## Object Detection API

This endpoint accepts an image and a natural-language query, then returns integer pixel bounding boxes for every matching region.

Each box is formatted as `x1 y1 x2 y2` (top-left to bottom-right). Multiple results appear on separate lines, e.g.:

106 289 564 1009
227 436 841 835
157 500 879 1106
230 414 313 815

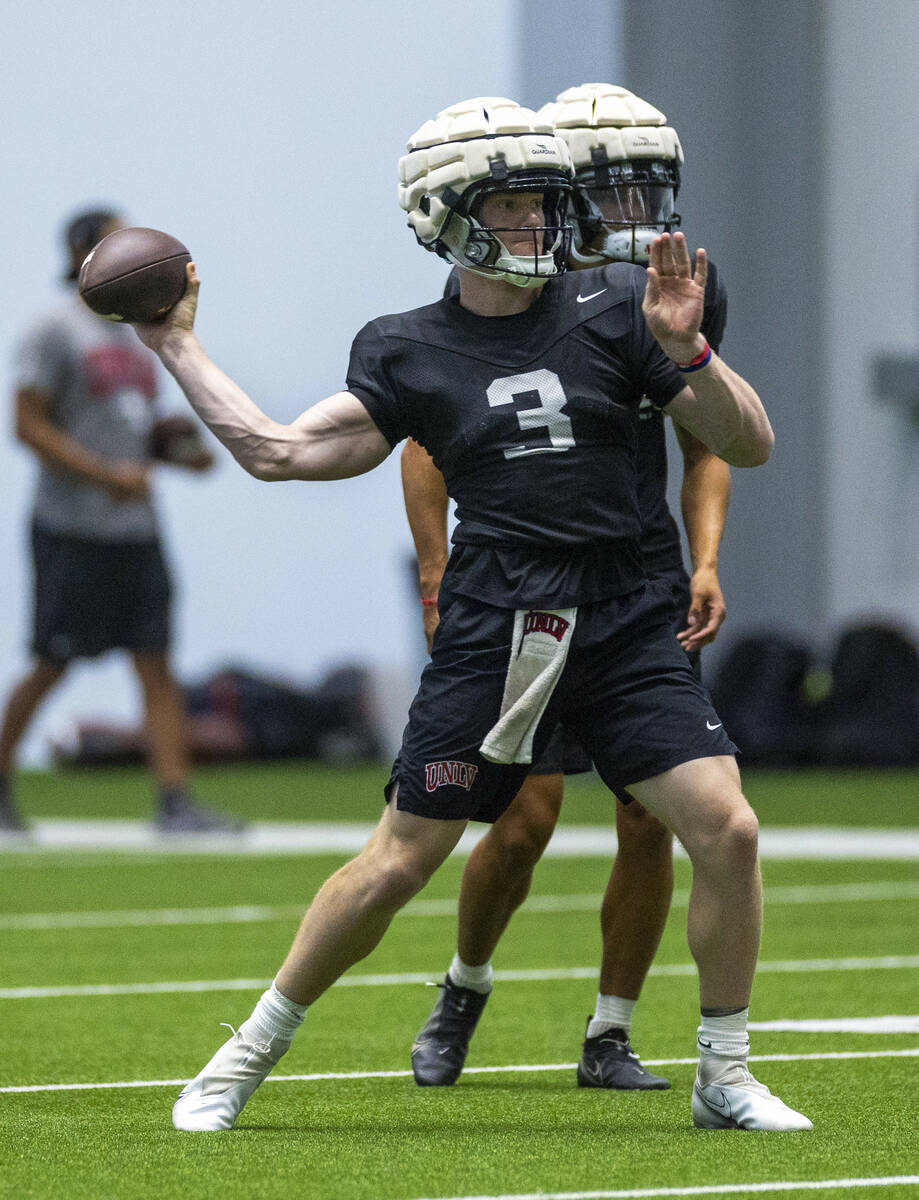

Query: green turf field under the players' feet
0 766 919 1200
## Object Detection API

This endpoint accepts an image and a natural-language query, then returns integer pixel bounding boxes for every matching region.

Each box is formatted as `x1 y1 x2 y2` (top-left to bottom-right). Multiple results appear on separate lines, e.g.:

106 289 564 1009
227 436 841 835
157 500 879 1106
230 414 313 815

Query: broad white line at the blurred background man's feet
0 820 919 862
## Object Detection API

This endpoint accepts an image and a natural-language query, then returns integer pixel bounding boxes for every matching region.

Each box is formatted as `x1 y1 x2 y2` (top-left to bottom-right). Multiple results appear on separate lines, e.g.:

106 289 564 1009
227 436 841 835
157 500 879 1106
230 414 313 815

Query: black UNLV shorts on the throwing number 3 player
386 582 737 822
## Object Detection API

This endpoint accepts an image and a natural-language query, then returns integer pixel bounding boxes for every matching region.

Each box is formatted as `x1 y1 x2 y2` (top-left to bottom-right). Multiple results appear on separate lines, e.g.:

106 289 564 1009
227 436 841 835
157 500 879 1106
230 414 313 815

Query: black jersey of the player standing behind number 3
444 259 727 581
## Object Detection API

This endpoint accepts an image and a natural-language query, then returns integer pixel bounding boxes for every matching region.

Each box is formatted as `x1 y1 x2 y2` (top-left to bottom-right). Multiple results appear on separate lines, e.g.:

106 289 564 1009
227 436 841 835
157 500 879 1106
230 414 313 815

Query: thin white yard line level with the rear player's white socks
0 954 919 1000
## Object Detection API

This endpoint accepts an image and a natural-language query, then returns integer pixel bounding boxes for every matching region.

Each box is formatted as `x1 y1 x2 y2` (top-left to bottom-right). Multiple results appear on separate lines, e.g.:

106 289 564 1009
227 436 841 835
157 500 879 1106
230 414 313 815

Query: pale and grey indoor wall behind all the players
0 0 919 762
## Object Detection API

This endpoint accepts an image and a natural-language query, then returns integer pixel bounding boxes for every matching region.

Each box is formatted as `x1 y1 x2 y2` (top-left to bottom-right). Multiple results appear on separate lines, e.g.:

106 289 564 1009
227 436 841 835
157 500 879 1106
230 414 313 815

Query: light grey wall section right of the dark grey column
823 0 919 634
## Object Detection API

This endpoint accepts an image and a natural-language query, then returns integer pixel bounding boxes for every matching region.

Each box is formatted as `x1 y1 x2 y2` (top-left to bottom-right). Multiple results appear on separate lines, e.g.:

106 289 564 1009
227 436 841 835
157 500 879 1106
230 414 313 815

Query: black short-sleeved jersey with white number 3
347 263 686 607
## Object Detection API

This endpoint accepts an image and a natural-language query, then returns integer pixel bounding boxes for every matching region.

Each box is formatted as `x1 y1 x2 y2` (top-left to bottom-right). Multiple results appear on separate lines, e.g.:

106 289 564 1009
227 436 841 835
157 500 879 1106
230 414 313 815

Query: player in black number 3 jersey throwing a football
138 97 811 1129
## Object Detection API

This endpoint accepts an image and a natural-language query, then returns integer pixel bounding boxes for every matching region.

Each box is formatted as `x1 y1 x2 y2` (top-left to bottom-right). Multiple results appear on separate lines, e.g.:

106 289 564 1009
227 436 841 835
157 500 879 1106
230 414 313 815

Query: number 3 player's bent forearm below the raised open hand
666 352 775 467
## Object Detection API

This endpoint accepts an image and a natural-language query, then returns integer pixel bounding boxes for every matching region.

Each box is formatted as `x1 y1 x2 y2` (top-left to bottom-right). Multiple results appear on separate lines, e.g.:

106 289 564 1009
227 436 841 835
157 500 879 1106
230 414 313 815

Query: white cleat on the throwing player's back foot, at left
173 1032 290 1132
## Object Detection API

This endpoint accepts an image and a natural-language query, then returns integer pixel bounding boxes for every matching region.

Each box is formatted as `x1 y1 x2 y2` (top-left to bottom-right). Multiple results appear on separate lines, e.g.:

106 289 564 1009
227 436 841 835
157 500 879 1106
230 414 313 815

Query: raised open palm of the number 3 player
642 233 708 362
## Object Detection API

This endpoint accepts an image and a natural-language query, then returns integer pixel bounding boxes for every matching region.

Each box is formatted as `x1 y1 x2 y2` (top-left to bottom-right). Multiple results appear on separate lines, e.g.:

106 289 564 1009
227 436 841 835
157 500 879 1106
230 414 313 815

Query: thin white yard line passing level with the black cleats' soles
0 1048 919 1096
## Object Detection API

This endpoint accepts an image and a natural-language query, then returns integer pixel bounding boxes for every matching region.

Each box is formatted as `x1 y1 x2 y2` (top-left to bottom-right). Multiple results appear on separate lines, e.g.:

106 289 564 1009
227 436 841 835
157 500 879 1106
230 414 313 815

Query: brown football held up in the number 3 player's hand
77 228 192 322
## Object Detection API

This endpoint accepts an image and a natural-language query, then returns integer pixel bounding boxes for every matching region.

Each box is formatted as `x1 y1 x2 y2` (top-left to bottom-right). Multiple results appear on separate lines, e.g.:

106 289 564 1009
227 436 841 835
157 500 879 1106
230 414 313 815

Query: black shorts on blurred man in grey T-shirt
31 524 172 664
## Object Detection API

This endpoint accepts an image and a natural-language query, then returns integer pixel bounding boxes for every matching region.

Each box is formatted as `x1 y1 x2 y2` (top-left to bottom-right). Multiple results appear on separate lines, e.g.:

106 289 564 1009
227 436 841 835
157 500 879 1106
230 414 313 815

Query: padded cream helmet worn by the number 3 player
398 96 572 288
